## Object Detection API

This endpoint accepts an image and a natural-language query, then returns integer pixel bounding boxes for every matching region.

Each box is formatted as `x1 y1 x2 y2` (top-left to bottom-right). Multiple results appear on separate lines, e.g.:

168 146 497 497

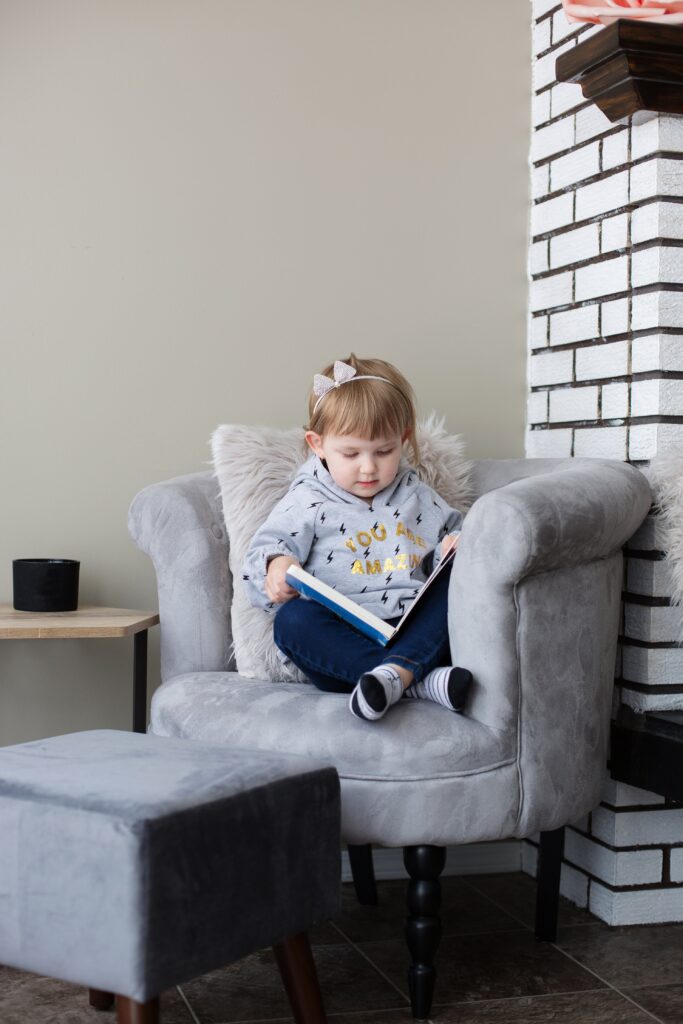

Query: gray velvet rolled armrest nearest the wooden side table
128 472 234 681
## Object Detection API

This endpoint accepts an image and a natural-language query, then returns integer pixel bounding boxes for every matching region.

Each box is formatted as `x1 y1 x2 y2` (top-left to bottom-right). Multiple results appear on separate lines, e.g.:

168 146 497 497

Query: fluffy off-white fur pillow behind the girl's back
211 413 473 682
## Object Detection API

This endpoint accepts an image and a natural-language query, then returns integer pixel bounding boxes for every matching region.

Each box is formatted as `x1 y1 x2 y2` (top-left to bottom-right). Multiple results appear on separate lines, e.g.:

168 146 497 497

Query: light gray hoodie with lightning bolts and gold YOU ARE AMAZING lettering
242 455 463 618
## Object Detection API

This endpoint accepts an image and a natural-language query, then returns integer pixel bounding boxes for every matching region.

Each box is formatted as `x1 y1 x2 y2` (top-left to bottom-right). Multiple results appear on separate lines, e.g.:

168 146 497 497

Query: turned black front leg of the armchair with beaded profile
403 846 445 1021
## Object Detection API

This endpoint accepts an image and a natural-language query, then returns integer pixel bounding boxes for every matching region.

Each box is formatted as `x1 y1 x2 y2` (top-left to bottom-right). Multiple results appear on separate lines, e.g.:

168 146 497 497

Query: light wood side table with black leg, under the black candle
0 604 159 732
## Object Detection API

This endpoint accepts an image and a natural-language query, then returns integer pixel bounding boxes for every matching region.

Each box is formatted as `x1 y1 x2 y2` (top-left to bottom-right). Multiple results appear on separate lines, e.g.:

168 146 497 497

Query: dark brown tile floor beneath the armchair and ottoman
0 874 683 1024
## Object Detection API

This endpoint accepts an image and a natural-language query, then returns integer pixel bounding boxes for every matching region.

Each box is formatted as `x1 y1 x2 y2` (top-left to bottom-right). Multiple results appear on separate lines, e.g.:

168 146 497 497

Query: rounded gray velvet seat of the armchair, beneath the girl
151 672 518 846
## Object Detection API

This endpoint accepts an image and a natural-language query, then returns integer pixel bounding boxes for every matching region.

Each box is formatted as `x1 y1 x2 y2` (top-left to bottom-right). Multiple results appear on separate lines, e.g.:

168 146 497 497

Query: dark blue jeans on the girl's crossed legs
272 566 451 693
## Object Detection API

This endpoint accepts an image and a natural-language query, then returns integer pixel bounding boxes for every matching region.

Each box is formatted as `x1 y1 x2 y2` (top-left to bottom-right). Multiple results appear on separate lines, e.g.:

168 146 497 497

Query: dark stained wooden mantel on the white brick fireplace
555 18 683 121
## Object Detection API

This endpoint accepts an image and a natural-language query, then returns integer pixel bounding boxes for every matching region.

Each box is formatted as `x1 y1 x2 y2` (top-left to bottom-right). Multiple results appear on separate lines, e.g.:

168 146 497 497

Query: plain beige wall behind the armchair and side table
0 0 529 743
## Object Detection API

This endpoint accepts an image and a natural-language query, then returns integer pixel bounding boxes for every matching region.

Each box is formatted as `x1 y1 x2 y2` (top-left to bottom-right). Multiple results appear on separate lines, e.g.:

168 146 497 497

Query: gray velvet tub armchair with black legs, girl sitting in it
129 459 651 1020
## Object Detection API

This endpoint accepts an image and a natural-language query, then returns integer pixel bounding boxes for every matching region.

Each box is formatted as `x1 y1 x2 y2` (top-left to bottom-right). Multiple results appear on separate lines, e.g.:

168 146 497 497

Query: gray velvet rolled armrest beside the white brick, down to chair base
449 460 651 835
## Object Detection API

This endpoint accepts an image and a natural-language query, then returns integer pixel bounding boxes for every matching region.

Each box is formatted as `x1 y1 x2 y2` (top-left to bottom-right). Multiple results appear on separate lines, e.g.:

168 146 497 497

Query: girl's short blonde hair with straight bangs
304 352 420 466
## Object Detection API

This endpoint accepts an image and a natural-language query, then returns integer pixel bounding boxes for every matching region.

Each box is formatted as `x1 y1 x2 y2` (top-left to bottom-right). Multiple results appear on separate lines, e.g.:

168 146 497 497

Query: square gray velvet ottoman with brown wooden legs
0 730 340 1022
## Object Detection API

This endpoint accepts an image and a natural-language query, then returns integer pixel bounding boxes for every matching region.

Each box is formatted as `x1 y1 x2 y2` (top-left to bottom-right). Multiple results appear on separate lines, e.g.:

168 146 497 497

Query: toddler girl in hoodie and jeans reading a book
243 354 472 721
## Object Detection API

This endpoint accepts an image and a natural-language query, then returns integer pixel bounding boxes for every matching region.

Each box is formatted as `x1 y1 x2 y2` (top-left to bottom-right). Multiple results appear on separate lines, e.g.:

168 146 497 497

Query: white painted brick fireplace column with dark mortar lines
524 0 683 925
